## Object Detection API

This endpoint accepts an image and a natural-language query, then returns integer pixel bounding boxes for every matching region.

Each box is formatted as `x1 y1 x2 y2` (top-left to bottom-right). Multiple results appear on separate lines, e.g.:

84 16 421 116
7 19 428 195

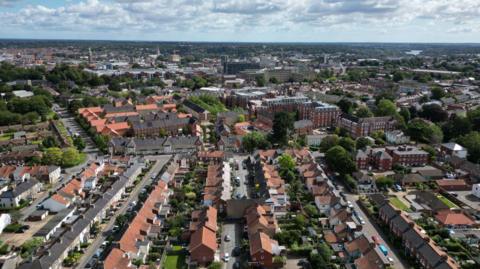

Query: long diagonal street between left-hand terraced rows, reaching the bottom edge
75 155 171 268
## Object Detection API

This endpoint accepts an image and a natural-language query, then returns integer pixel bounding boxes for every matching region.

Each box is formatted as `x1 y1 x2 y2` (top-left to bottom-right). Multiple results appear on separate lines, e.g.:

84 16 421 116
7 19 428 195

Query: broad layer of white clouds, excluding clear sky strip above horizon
0 0 480 41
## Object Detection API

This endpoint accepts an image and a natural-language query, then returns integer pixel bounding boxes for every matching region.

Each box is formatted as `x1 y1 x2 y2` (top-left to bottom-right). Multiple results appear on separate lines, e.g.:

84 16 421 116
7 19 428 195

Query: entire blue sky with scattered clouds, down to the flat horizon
0 0 480 43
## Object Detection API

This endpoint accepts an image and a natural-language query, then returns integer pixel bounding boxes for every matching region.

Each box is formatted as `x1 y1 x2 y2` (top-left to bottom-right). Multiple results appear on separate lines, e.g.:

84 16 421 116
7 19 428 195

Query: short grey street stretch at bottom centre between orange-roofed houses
220 222 242 269
